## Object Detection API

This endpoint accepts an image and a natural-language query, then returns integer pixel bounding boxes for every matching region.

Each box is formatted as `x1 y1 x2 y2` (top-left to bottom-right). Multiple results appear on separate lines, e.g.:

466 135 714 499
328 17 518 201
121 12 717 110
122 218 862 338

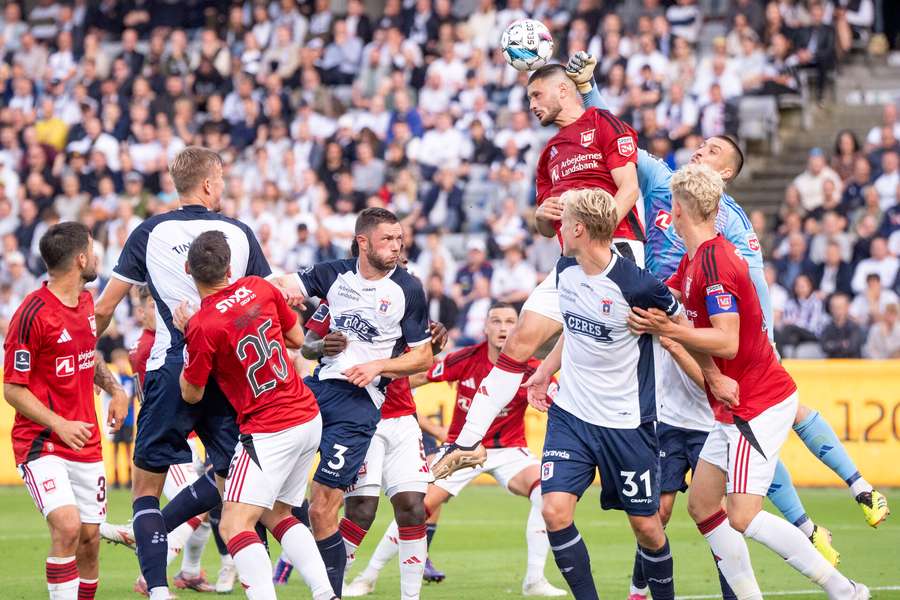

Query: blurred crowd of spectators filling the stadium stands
0 0 884 355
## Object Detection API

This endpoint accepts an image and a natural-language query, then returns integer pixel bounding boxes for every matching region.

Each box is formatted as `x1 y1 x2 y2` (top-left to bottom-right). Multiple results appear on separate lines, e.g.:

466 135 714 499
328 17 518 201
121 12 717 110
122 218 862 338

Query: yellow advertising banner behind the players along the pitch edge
0 360 900 486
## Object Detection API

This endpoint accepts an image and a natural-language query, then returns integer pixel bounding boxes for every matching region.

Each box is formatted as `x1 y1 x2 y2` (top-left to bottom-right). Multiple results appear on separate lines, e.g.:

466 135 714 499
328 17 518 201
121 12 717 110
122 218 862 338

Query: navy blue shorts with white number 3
303 375 381 490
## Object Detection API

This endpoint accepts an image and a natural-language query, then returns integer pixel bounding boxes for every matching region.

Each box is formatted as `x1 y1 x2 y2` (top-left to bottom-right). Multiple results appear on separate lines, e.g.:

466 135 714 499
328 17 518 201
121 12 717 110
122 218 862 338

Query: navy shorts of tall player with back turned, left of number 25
134 361 238 477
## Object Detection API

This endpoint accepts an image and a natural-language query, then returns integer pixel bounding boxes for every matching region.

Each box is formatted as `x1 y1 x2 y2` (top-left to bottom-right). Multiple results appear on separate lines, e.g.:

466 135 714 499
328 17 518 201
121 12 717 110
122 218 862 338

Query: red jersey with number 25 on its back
184 276 319 433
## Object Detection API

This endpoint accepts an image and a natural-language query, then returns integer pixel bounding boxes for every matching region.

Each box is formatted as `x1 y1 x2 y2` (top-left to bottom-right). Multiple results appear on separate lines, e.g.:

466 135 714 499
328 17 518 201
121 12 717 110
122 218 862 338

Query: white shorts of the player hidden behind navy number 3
344 415 433 498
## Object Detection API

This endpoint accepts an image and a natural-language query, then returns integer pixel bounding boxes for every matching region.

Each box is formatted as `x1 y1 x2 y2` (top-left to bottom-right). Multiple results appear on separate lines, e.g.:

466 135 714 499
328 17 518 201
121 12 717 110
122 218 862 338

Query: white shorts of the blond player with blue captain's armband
700 392 800 496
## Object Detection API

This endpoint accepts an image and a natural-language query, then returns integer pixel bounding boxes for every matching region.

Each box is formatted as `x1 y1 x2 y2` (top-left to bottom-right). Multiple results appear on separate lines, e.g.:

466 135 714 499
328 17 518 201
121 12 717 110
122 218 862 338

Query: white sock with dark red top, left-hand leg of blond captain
697 510 760 600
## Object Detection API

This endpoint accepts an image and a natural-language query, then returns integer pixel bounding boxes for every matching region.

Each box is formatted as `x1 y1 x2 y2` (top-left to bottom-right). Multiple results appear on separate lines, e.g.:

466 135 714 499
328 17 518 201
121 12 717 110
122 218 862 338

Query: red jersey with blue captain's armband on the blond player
667 235 797 423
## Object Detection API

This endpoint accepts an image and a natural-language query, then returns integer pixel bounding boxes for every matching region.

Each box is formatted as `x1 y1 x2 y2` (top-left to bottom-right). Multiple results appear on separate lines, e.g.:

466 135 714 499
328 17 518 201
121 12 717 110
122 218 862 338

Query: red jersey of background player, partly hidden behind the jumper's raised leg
428 342 556 448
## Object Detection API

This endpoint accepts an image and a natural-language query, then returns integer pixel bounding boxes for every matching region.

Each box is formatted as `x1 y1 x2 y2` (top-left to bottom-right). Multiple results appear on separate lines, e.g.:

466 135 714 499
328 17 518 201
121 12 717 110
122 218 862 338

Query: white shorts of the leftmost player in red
19 455 106 523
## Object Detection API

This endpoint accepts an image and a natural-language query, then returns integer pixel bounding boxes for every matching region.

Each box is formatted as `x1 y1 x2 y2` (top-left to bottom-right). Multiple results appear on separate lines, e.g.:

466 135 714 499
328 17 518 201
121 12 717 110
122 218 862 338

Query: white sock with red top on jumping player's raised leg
456 352 528 448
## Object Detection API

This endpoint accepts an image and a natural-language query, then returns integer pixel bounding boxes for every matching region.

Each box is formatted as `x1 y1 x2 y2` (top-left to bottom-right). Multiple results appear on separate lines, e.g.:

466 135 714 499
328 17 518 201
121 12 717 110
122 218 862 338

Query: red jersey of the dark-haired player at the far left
3 283 103 464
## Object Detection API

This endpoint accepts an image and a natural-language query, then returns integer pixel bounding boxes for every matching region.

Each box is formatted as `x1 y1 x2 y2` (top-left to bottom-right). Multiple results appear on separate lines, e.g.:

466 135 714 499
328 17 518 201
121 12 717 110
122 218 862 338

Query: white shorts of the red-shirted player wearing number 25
224 415 322 508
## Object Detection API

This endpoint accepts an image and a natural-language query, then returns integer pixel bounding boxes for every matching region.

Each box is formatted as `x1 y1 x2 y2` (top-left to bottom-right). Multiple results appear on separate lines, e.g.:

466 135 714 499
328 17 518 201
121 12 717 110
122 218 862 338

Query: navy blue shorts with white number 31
541 404 659 516
